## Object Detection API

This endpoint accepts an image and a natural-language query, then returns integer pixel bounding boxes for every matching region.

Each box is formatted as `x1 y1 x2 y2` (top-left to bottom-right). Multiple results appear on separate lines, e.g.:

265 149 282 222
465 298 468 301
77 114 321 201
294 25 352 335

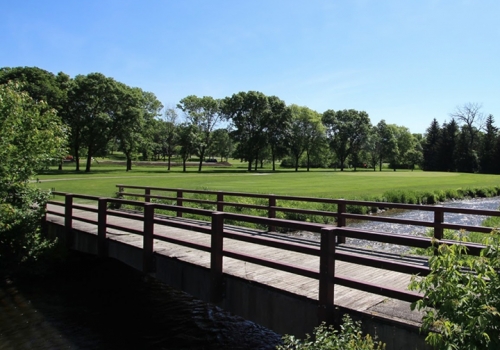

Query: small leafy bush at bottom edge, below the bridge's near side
277 315 385 350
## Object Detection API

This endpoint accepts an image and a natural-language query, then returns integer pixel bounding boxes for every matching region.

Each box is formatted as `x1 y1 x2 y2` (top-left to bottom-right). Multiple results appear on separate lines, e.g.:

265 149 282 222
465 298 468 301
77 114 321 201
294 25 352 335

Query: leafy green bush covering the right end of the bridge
409 232 500 350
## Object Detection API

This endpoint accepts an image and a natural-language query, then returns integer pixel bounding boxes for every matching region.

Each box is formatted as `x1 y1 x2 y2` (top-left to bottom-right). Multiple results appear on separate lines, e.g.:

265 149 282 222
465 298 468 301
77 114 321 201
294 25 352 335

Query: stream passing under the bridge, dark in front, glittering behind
0 197 500 350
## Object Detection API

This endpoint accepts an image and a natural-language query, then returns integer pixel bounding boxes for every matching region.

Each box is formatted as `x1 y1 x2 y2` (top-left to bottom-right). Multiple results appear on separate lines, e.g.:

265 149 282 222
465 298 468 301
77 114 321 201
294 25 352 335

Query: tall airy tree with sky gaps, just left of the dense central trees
177 95 221 171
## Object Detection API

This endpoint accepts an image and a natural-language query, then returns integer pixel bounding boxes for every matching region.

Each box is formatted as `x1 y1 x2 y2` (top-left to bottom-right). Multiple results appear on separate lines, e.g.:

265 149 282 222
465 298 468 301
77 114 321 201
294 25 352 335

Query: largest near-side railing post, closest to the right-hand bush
318 227 336 324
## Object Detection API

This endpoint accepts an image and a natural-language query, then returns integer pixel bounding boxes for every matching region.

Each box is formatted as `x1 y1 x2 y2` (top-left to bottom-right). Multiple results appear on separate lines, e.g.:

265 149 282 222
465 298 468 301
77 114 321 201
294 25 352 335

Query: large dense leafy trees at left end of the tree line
0 67 163 171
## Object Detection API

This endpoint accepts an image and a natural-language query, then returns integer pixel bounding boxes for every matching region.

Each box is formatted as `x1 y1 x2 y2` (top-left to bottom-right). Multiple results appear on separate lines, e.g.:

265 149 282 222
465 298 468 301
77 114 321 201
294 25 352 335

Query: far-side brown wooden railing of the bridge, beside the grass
116 184 500 243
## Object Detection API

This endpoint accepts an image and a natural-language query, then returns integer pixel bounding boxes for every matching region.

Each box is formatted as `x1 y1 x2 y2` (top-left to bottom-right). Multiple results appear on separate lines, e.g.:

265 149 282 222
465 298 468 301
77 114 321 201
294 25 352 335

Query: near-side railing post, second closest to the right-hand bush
210 212 224 303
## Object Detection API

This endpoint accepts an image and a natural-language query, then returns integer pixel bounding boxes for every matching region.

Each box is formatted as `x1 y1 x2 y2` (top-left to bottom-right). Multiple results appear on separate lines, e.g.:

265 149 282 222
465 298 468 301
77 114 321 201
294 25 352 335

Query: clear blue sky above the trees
0 0 500 133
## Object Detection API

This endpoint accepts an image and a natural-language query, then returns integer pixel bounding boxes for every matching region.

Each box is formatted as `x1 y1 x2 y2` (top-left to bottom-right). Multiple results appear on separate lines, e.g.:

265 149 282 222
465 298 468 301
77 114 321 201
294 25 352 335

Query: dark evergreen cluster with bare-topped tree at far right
422 103 500 174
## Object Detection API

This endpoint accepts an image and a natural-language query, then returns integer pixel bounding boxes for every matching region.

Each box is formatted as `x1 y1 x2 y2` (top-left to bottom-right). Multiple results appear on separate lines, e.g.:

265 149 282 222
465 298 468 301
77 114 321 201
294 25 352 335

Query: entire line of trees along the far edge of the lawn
0 67 500 172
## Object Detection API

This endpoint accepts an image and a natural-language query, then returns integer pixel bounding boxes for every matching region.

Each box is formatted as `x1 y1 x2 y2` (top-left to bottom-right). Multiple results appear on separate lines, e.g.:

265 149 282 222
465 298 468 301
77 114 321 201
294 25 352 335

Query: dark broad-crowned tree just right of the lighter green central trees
322 109 371 171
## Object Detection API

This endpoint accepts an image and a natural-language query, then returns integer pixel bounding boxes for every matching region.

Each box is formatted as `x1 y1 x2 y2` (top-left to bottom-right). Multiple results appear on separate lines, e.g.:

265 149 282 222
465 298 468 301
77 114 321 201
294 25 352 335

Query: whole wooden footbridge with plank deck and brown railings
46 185 500 349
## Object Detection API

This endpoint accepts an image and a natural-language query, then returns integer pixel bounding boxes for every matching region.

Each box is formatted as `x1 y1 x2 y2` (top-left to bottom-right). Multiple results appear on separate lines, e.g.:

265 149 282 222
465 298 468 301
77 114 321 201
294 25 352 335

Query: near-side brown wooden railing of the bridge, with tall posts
47 192 492 324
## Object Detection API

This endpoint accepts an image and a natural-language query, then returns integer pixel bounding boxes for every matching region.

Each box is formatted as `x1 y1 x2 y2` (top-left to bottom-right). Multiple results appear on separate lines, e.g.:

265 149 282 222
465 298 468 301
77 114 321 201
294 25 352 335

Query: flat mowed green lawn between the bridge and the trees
36 164 500 199
